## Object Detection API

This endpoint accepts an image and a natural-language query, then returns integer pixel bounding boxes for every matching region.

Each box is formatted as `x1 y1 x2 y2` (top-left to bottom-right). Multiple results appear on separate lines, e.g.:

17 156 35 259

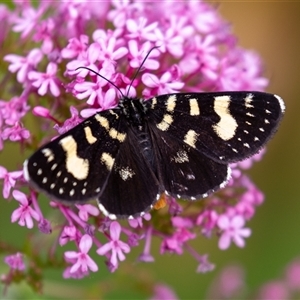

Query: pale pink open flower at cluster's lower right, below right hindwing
218 215 251 250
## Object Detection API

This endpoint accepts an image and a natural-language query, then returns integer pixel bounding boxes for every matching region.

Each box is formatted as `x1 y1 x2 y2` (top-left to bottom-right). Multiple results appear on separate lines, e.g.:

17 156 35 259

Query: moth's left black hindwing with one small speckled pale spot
98 128 161 219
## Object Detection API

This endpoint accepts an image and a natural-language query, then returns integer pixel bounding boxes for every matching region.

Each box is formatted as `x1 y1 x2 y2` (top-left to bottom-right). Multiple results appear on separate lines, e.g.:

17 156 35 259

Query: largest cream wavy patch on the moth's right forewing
212 96 238 141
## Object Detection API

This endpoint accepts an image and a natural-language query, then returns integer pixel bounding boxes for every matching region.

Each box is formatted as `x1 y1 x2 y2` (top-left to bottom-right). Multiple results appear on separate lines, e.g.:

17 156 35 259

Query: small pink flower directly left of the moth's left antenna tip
28 62 60 97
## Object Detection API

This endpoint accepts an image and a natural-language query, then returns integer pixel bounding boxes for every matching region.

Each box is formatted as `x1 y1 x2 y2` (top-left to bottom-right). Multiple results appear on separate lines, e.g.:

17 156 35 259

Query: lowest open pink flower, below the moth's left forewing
64 234 98 273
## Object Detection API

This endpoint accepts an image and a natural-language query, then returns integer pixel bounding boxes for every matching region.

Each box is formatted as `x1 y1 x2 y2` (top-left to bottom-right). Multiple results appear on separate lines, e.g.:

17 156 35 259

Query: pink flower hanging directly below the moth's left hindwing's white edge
97 221 130 268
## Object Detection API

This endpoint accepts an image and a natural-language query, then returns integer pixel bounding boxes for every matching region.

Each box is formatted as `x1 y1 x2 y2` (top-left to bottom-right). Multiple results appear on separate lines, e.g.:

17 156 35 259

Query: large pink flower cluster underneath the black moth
0 0 267 290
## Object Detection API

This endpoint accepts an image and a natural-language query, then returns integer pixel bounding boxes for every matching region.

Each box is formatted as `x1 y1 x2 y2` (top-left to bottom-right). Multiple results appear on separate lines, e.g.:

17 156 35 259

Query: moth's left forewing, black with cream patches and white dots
24 110 127 202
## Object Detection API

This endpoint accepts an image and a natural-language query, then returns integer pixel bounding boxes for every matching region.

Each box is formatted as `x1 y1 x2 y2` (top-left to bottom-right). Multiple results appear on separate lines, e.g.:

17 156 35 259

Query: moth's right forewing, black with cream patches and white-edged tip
148 92 285 163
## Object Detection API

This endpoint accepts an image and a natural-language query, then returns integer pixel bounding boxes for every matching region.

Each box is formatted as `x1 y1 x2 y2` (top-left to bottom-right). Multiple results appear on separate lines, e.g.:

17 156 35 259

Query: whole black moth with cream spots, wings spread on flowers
24 92 285 219
